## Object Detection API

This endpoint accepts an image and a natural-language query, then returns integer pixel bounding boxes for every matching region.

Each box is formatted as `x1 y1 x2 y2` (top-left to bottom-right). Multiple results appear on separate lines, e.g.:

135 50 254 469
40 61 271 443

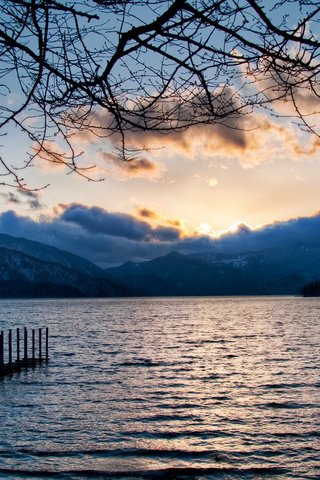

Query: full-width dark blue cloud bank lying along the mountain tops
0 204 320 267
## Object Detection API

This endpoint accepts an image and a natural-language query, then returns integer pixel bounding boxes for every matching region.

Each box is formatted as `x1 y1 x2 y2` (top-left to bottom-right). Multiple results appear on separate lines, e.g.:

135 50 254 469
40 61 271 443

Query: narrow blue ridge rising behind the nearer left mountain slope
0 233 104 277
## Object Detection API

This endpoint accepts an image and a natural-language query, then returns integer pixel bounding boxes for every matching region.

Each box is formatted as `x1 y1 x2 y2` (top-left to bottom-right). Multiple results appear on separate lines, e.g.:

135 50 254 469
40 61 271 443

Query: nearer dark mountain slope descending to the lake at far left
0 238 127 298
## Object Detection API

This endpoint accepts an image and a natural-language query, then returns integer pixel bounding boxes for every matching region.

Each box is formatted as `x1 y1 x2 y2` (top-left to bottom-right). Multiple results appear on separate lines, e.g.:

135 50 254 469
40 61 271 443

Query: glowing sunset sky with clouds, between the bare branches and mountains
0 1 320 267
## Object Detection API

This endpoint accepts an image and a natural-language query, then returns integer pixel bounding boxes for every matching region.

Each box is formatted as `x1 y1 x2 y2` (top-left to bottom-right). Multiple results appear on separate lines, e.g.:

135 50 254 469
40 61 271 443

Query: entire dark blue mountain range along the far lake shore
0 234 320 298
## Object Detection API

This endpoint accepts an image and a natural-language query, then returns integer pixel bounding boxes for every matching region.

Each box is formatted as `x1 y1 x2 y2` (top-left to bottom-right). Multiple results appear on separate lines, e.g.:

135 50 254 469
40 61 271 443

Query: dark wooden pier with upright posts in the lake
0 327 49 378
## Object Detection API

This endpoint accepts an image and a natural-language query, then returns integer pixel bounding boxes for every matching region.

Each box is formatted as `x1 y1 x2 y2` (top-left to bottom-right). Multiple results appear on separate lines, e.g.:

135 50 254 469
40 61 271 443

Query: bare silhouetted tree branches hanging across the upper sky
0 0 320 187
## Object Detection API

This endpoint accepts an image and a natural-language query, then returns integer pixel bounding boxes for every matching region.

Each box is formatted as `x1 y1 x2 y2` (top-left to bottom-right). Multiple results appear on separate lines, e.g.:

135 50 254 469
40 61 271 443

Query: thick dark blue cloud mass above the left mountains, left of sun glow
0 204 181 266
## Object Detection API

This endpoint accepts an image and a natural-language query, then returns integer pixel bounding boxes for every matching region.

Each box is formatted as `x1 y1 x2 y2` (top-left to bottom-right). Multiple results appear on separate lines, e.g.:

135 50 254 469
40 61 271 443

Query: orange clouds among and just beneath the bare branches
69 87 320 172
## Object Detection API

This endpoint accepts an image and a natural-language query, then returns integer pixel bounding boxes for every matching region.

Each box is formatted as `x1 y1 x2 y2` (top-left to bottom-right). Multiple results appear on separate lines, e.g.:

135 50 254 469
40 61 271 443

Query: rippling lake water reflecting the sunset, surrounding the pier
0 297 320 480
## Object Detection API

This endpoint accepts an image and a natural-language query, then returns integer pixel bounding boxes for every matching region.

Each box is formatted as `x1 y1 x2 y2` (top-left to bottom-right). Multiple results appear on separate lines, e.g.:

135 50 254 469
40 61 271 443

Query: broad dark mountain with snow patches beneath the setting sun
106 244 320 296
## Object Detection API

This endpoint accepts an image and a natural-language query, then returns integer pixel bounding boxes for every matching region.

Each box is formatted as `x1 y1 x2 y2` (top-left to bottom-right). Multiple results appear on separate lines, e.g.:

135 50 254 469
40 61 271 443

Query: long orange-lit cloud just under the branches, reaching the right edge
123 113 320 168
